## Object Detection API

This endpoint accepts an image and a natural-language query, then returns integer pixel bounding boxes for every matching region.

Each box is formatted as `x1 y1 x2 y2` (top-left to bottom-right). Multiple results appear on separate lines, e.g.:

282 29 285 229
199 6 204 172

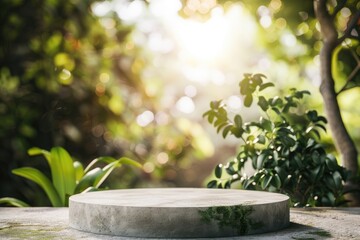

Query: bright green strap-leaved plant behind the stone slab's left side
0 147 141 207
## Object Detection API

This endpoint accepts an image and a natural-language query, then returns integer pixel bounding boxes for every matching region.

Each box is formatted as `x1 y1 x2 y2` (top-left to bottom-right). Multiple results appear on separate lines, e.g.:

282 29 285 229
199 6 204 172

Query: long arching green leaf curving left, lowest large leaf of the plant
12 167 63 207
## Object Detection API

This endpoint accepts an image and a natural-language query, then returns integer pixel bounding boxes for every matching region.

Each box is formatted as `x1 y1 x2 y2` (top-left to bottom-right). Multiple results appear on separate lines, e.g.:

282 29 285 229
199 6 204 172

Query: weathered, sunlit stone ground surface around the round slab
0 207 360 240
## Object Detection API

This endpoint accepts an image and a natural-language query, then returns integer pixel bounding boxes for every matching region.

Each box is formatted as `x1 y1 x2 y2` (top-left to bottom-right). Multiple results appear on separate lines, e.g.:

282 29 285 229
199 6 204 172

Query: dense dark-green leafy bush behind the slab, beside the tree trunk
204 74 347 206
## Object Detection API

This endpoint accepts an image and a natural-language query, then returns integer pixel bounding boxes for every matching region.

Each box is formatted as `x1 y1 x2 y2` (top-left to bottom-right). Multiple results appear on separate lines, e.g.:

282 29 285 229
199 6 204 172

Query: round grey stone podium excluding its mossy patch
69 188 289 238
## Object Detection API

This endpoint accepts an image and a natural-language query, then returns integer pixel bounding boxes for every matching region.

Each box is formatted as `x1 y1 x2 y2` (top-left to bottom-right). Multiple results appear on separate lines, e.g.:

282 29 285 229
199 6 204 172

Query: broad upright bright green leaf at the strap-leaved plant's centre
50 147 76 204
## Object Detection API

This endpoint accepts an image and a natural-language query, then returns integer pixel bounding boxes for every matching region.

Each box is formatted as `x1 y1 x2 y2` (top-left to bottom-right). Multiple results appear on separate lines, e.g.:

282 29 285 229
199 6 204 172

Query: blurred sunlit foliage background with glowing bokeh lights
0 0 360 205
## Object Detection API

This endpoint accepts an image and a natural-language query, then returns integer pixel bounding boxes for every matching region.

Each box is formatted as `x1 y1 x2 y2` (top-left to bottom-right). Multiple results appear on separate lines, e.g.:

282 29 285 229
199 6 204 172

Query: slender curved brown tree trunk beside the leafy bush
314 0 360 206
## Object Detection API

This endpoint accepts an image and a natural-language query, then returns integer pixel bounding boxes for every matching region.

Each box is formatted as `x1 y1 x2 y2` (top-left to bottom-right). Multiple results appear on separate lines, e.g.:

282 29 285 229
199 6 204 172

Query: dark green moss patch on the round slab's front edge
199 205 261 235
